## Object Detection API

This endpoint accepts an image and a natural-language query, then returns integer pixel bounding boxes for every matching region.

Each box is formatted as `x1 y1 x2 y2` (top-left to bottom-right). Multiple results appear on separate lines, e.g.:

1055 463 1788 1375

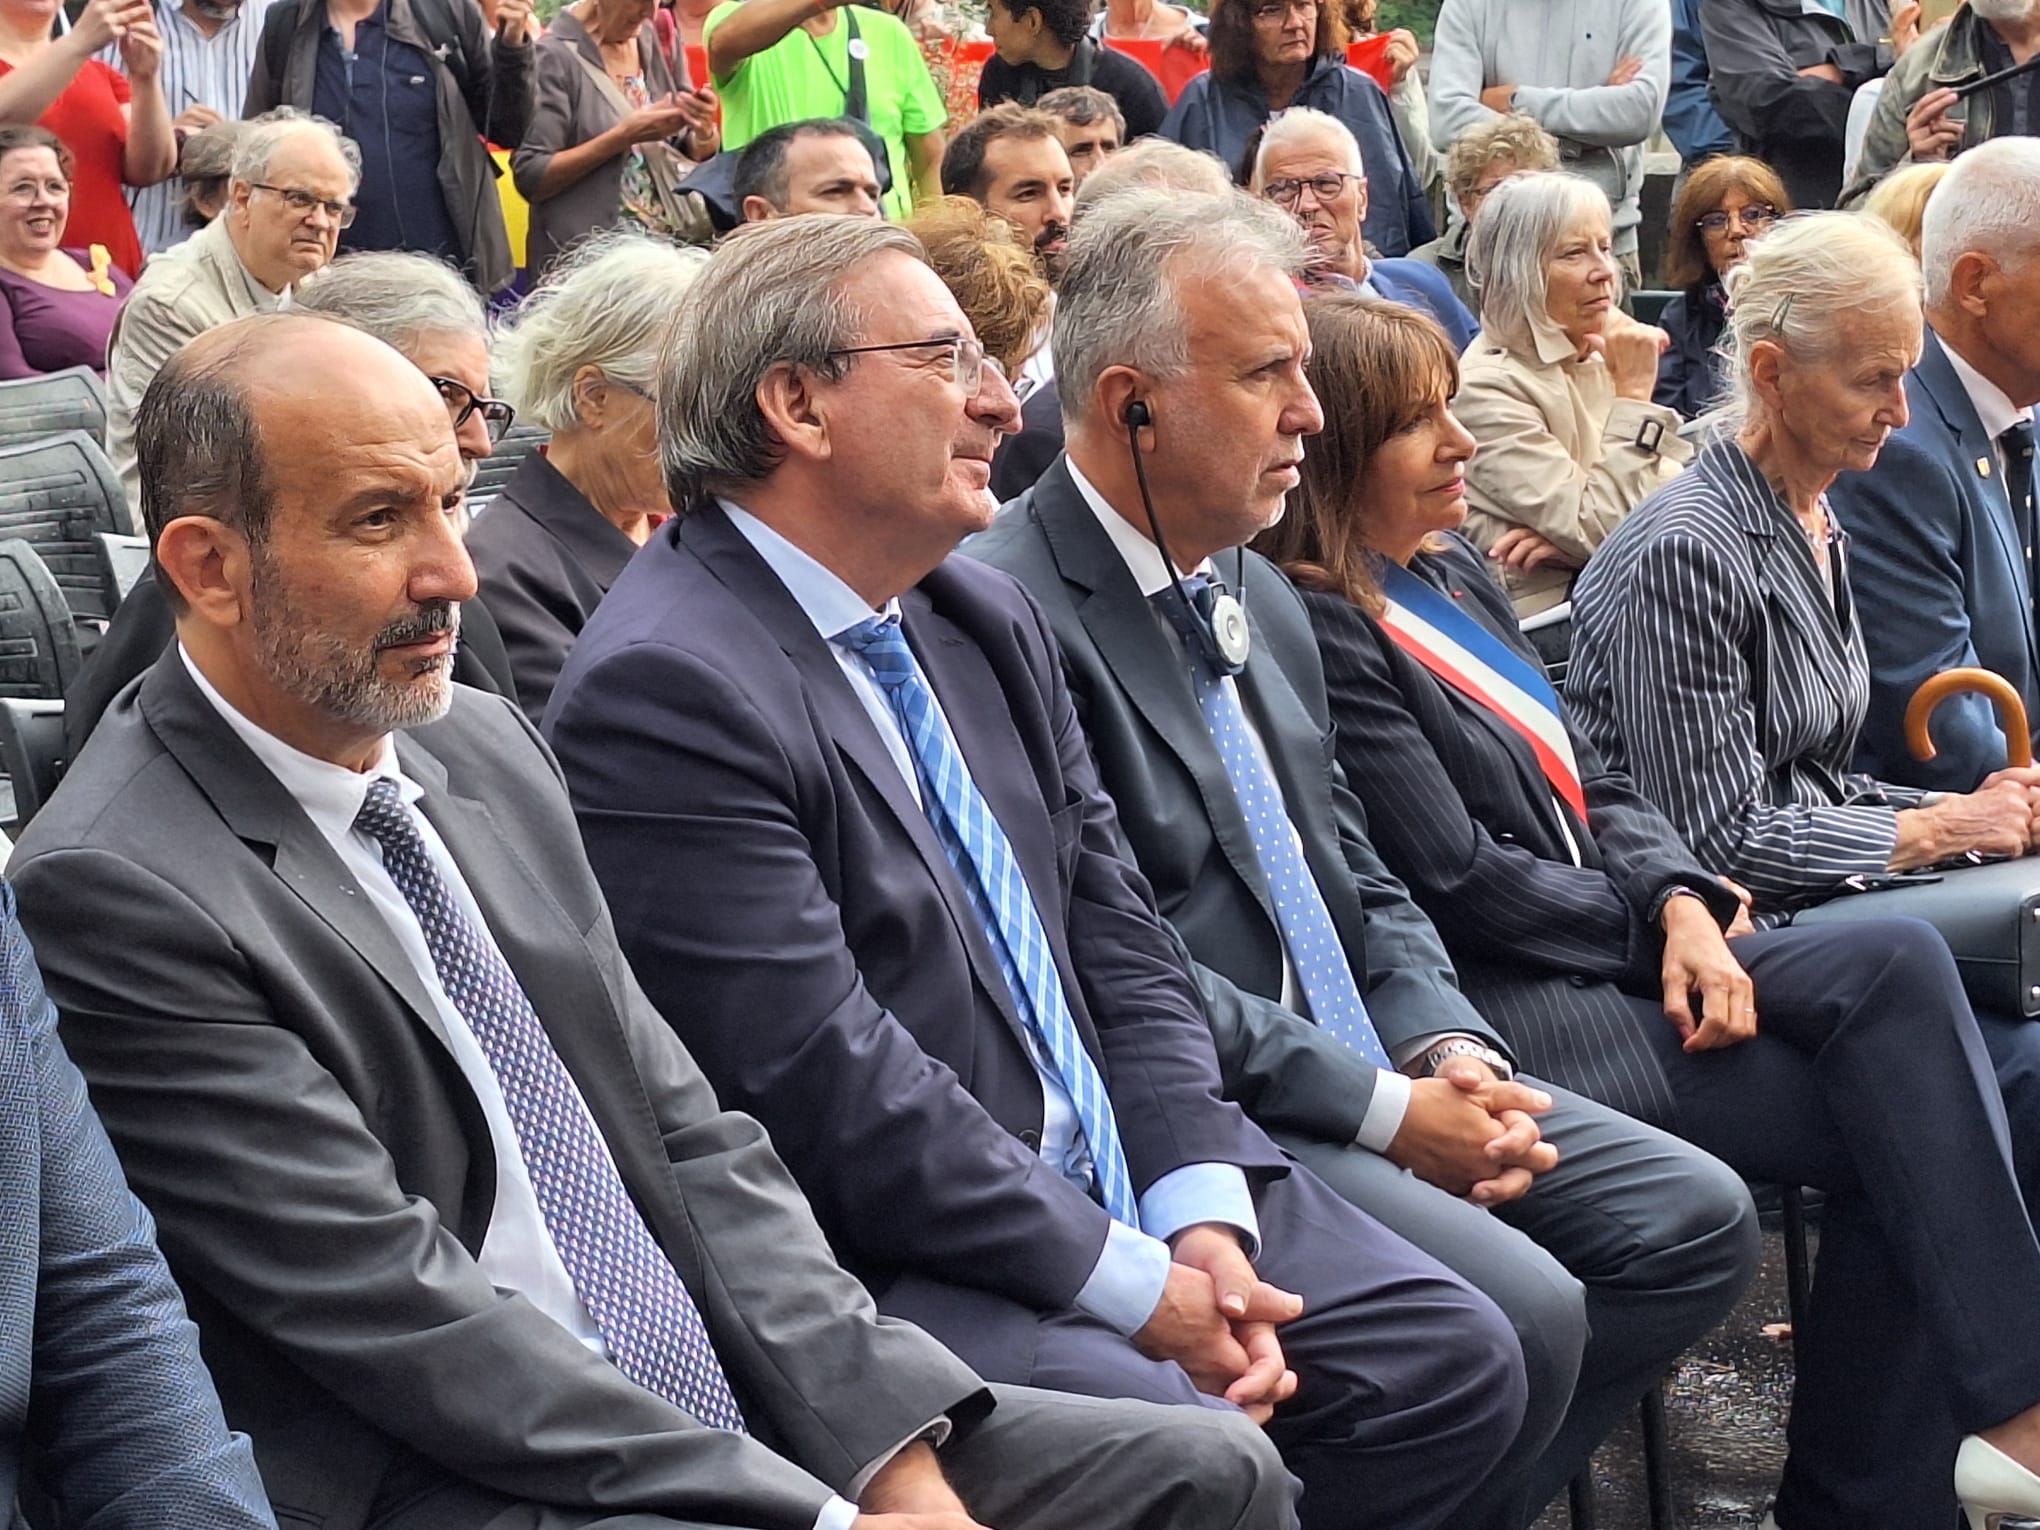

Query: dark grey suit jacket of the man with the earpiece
963 459 1503 1142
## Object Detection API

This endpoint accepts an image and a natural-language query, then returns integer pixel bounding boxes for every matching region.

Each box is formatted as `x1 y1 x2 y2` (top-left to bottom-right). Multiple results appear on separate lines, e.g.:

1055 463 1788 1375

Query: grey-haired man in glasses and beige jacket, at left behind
106 106 361 518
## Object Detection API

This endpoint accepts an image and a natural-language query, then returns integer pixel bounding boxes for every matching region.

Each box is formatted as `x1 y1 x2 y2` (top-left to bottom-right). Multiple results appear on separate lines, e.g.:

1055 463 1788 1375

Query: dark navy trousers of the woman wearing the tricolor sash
1632 920 2040 1530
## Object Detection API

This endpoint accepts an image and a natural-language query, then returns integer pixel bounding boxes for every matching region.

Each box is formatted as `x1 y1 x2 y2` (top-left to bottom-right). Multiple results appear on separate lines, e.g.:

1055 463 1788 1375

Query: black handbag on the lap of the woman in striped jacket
1791 857 2040 1020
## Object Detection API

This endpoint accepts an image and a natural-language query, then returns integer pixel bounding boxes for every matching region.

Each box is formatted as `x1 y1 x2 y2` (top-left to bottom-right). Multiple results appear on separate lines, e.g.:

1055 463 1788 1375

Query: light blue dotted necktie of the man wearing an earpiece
1161 573 1393 1069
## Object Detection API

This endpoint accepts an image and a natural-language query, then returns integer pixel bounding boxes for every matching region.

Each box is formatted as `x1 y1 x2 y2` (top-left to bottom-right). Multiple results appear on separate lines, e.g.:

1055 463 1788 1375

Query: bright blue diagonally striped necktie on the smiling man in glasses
834 616 1140 1228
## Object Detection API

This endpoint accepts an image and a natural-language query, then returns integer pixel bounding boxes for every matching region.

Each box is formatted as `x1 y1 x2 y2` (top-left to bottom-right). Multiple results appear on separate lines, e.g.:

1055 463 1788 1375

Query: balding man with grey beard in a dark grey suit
10 308 1289 1530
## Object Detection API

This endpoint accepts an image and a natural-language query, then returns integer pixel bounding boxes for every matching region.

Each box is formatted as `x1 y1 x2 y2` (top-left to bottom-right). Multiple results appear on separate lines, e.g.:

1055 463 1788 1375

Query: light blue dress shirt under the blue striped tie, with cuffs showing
722 500 1261 1334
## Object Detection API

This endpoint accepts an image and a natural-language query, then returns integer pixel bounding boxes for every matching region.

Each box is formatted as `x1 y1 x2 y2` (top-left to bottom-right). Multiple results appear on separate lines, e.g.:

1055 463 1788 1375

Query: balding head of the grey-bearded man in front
135 314 475 769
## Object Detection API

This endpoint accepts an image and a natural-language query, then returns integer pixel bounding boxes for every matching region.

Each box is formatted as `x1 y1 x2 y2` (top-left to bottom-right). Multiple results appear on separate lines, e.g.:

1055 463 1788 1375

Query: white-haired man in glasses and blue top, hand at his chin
1253 106 1479 351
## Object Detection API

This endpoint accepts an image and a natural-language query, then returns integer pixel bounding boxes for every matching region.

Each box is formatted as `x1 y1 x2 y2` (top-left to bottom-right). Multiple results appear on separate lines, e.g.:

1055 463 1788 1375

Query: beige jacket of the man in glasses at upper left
106 214 291 530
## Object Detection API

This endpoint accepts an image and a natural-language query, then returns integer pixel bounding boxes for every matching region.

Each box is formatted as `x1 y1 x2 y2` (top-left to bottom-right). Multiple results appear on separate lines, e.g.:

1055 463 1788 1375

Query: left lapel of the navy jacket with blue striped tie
679 506 1026 1038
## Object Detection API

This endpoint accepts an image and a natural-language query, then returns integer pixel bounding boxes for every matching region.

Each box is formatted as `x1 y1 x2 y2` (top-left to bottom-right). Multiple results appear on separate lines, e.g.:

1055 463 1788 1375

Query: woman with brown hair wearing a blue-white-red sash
1257 296 2040 1530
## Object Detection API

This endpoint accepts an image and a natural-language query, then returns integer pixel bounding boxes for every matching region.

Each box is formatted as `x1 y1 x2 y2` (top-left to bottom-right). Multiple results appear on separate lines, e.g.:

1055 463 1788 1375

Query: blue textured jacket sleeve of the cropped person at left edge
0 883 275 1530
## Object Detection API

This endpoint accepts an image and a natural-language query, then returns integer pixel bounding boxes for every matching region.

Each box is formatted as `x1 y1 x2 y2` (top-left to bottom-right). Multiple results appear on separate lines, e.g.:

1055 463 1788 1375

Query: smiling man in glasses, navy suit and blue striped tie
545 210 1524 1530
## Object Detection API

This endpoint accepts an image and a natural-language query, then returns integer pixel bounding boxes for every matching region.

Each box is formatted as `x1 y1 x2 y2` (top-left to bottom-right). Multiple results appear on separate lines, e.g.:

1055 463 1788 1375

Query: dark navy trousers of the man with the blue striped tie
879 1169 1526 1530
